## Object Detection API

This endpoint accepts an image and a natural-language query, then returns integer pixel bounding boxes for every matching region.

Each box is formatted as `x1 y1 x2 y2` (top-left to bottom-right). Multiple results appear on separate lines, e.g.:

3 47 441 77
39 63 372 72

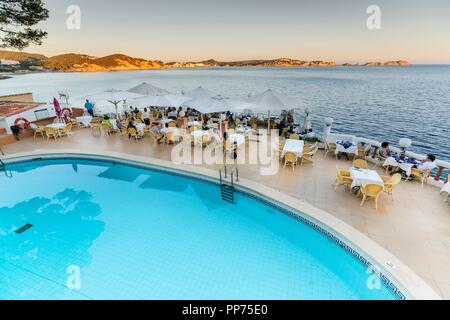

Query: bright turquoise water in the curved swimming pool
0 159 396 299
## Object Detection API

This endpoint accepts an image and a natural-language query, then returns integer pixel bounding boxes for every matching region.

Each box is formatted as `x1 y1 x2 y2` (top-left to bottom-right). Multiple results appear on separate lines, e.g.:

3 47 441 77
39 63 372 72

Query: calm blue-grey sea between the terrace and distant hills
0 65 450 161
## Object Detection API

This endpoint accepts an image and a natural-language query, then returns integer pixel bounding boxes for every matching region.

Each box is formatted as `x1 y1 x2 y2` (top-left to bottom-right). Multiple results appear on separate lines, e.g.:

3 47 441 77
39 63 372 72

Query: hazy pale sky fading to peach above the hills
24 0 450 63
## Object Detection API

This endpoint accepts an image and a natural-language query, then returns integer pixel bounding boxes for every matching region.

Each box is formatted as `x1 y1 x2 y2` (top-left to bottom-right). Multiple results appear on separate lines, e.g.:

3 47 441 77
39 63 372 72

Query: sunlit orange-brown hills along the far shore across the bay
0 50 410 72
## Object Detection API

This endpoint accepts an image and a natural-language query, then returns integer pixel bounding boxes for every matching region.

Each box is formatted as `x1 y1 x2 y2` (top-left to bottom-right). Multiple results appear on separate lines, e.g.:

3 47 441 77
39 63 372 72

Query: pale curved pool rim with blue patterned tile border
2 149 442 300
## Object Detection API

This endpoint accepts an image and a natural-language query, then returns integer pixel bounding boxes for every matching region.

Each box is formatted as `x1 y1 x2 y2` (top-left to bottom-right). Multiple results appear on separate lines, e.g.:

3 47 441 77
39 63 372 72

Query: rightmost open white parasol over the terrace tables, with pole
247 89 301 131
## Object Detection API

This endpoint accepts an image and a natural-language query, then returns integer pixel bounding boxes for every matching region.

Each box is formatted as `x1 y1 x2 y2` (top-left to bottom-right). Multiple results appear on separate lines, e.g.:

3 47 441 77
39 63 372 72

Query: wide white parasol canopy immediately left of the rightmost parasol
183 96 256 114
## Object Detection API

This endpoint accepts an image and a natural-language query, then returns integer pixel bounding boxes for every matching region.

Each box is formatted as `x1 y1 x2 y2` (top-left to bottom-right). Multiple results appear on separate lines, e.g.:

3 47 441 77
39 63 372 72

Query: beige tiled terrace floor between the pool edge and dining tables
3 129 450 299
